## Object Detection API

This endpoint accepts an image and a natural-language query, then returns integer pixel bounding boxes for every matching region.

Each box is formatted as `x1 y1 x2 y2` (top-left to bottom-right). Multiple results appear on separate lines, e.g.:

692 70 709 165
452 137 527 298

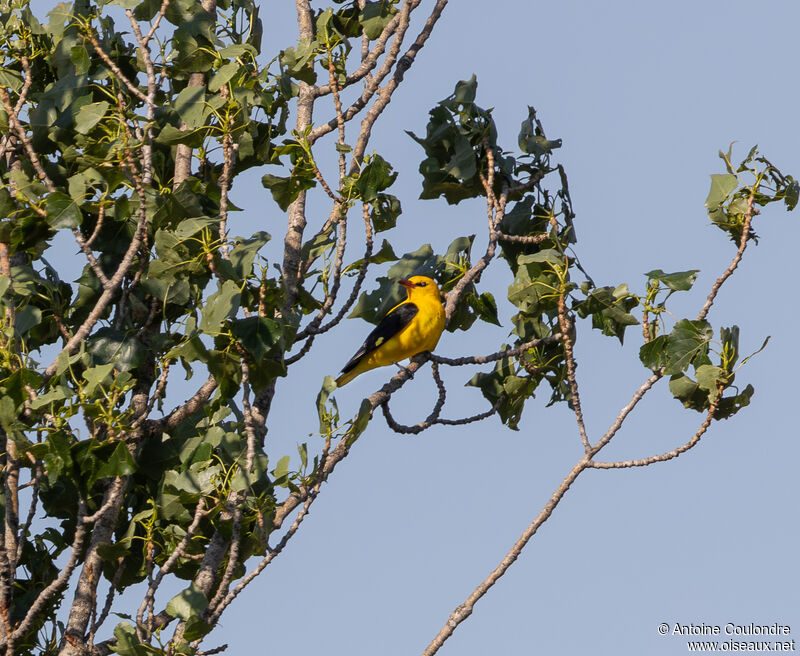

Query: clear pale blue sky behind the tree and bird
29 0 800 656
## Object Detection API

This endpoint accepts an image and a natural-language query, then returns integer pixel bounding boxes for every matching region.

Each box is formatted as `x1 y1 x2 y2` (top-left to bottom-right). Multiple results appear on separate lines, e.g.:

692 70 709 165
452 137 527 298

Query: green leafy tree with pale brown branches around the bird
0 0 798 656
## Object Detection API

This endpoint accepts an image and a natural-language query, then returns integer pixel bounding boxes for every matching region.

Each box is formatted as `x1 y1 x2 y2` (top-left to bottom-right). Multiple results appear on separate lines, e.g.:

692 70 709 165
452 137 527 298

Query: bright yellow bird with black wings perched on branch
336 276 445 387
